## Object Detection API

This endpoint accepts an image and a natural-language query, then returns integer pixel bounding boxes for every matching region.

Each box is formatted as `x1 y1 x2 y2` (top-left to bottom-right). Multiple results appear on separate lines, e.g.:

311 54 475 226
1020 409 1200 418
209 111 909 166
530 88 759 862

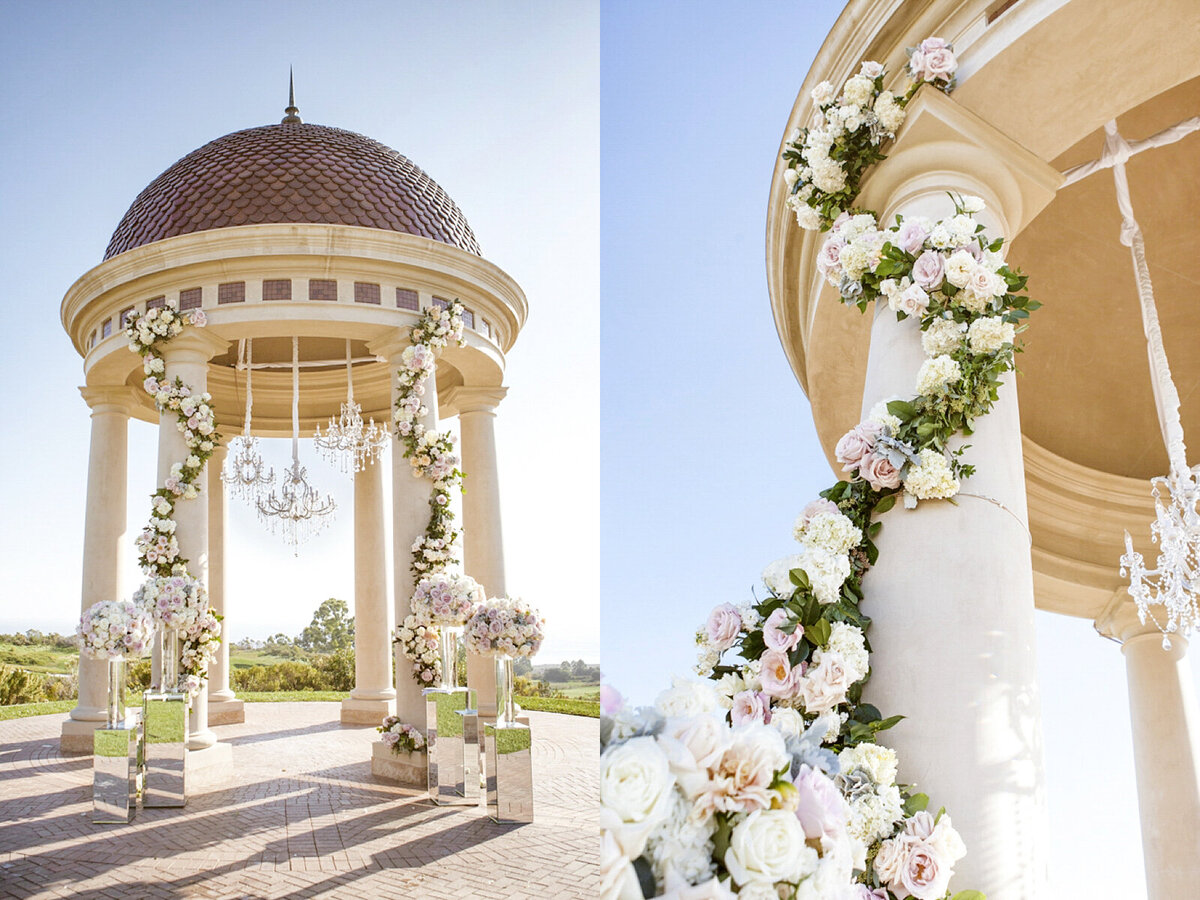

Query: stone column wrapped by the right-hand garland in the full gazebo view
374 336 438 726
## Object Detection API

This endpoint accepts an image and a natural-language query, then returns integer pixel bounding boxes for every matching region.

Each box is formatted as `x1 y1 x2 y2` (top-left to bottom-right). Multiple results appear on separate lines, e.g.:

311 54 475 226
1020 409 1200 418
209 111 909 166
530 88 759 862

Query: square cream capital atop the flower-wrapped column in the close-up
856 88 1063 238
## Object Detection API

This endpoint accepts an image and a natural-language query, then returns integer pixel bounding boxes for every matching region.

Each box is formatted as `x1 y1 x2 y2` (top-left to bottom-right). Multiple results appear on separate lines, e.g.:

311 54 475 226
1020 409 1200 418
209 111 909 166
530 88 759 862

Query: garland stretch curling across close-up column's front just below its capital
817 194 1040 506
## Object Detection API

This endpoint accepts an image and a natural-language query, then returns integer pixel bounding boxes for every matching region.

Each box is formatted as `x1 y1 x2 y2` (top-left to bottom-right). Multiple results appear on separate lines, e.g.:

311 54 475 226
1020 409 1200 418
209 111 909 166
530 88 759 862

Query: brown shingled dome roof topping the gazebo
104 122 479 259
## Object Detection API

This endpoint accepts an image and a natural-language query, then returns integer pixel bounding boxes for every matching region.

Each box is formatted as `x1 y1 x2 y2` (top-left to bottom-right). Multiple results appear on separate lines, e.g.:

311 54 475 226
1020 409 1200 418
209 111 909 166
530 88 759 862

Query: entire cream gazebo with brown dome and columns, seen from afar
61 91 527 764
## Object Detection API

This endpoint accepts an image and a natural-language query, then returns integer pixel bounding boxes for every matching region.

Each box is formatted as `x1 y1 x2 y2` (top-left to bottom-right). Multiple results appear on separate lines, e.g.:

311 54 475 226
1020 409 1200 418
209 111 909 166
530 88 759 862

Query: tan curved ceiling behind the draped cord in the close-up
1009 79 1200 487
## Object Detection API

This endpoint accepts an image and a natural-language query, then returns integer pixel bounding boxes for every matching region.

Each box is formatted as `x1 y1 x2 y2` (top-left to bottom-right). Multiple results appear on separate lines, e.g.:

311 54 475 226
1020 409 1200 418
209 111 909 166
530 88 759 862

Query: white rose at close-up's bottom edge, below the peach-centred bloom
725 809 820 886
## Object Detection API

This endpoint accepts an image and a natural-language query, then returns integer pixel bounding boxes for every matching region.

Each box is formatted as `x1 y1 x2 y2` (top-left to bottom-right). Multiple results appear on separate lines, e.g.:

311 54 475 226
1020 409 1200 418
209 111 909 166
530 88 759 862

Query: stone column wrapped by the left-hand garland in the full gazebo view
158 328 226 750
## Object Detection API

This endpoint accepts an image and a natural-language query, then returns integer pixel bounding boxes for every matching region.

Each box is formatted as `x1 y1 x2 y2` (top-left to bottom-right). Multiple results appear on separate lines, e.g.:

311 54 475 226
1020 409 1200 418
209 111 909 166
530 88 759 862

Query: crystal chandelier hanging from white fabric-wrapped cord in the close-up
1067 120 1200 649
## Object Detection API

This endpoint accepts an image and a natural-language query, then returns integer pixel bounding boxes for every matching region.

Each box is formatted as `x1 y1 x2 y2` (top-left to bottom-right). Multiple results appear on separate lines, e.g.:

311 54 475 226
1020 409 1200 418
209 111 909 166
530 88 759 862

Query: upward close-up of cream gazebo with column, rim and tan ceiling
767 0 1200 900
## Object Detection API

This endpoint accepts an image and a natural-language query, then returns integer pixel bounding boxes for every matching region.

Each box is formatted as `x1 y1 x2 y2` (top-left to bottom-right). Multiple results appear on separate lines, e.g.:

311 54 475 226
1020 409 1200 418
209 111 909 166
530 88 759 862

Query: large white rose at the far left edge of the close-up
600 737 674 859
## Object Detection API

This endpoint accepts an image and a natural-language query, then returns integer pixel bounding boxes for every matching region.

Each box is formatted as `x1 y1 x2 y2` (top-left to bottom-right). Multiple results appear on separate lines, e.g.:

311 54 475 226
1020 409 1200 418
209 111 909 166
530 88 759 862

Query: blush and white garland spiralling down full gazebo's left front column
125 306 222 695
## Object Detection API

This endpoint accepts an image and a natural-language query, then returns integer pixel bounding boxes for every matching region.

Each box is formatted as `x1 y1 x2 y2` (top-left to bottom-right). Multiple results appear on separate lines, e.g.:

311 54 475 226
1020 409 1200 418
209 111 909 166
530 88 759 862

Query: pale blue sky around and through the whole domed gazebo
0 0 599 661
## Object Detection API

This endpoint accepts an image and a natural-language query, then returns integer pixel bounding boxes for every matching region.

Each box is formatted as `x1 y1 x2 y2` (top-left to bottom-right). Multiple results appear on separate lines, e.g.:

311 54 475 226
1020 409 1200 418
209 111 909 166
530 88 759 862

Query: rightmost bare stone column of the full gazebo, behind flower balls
454 388 508 716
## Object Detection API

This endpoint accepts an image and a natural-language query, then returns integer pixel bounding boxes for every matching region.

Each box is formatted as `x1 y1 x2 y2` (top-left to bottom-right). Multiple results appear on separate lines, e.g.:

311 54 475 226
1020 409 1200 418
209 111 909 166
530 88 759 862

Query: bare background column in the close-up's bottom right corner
1096 588 1200 900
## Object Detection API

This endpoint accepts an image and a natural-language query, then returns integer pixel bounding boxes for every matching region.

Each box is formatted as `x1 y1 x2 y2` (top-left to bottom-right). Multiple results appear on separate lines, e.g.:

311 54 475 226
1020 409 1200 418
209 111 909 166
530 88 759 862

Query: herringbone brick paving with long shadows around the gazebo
0 703 599 900
